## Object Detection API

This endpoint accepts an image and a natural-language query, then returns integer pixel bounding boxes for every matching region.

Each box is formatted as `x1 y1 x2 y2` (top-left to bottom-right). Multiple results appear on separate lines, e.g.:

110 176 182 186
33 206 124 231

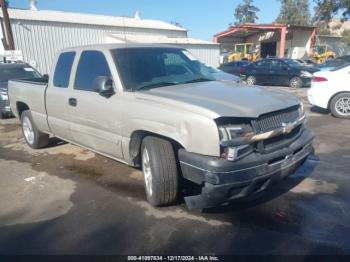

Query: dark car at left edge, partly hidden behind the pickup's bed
0 63 42 119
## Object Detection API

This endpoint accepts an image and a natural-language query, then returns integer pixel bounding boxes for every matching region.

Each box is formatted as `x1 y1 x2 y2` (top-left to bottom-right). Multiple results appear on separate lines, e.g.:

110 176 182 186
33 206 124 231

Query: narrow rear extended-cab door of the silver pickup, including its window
46 52 76 141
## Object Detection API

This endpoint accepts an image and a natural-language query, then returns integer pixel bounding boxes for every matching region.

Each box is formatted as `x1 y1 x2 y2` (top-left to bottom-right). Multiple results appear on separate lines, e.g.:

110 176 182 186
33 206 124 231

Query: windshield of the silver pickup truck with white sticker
112 47 215 91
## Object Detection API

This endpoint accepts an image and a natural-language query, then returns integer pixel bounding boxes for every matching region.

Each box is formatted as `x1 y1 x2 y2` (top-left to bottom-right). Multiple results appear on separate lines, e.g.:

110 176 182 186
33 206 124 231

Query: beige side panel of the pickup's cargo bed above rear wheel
8 78 49 132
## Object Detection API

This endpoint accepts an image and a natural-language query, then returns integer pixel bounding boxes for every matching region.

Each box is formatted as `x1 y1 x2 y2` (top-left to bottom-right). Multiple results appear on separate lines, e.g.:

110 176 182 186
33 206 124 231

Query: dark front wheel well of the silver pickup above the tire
129 130 184 167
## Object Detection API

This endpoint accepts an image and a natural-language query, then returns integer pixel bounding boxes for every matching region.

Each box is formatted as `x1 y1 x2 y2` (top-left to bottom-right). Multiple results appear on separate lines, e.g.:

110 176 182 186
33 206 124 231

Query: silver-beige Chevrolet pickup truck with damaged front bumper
9 44 313 209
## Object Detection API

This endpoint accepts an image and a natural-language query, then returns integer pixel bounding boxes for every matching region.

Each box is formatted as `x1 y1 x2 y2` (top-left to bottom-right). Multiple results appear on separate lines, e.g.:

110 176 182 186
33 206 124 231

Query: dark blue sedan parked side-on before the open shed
240 58 319 88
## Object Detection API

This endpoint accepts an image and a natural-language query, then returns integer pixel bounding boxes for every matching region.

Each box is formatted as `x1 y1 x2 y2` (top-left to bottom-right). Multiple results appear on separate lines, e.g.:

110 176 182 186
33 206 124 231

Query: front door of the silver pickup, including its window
70 50 123 160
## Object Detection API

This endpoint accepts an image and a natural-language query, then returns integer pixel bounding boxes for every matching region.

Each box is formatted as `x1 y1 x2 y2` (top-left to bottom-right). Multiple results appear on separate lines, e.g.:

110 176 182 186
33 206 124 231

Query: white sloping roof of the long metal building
0 9 187 31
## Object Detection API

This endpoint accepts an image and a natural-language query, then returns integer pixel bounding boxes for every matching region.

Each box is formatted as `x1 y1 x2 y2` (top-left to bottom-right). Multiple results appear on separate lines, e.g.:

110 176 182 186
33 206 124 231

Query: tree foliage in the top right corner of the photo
314 0 350 21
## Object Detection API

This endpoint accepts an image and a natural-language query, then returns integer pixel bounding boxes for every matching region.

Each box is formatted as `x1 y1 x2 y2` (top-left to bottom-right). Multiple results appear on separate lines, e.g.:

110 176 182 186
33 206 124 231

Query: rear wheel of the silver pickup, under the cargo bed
21 110 49 149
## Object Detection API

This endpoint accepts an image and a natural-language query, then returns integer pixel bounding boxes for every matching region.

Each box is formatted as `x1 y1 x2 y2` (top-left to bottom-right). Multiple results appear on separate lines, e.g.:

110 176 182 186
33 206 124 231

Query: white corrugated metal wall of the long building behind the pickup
11 20 187 74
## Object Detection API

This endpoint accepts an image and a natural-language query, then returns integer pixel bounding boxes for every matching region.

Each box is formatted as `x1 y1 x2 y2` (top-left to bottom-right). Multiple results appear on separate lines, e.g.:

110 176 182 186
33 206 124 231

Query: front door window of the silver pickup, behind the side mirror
74 51 111 91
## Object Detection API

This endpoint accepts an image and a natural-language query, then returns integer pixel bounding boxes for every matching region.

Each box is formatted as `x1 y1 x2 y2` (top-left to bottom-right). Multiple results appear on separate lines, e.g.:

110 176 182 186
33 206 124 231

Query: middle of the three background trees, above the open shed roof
276 0 311 25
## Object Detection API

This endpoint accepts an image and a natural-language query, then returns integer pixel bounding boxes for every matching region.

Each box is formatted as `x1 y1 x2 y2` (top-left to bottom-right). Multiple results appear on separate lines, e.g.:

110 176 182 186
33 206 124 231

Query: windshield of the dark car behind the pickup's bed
0 65 41 82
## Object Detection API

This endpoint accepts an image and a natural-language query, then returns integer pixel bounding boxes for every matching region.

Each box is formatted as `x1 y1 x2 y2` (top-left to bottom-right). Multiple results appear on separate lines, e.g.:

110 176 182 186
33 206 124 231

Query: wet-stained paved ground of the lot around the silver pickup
0 87 350 255
